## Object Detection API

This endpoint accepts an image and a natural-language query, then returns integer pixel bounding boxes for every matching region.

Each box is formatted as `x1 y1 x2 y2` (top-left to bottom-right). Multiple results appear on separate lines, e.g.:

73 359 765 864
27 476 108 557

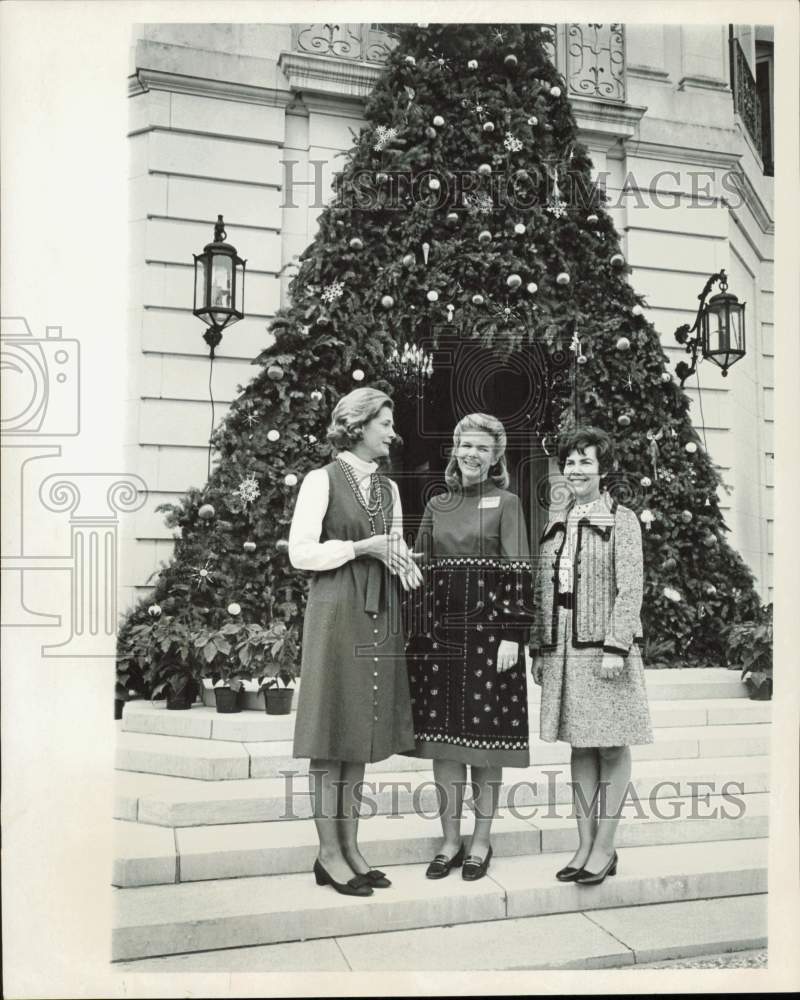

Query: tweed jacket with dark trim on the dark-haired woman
531 493 644 655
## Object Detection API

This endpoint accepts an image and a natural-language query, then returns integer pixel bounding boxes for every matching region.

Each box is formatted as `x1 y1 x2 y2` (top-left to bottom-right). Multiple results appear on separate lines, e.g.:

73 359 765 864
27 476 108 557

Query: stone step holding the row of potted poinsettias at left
122 692 772 743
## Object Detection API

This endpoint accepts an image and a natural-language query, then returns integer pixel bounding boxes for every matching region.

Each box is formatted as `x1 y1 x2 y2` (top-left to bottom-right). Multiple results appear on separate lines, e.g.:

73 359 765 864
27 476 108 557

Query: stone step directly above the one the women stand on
112 793 769 888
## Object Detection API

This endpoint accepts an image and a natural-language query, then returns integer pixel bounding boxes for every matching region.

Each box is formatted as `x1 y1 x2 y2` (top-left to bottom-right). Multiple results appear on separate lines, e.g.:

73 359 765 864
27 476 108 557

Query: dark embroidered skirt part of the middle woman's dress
406 558 530 767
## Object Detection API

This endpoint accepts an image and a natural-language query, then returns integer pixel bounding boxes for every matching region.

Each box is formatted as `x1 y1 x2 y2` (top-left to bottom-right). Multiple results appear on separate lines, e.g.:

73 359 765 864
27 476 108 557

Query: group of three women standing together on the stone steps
289 389 653 896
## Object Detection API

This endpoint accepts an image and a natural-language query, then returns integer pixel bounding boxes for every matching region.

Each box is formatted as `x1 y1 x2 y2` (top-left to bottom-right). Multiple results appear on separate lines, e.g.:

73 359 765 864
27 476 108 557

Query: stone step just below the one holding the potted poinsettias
116 723 770 781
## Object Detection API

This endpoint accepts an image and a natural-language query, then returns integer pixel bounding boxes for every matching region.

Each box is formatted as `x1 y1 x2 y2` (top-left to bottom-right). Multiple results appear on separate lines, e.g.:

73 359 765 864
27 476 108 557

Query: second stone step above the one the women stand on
114 755 770 826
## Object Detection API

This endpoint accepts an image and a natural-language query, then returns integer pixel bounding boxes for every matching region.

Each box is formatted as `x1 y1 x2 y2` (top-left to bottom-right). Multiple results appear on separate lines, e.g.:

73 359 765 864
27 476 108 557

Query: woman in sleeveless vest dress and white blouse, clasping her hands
289 388 422 896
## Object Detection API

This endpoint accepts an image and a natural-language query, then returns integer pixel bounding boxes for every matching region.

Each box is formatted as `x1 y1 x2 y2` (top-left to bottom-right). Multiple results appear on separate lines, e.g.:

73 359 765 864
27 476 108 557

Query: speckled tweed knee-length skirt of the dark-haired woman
539 608 654 747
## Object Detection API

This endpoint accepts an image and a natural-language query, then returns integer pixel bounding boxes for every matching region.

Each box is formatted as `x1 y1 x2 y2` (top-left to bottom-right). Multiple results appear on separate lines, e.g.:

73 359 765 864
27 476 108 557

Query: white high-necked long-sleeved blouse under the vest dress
289 451 403 570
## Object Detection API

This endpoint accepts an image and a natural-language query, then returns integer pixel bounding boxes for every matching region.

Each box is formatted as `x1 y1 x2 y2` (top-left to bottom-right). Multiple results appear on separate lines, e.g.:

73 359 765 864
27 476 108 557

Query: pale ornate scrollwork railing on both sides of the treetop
292 24 625 103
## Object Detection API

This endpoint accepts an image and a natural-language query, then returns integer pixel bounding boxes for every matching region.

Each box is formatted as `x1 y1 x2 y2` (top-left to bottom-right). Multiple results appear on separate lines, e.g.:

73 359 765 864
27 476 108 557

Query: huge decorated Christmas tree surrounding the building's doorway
115 24 759 696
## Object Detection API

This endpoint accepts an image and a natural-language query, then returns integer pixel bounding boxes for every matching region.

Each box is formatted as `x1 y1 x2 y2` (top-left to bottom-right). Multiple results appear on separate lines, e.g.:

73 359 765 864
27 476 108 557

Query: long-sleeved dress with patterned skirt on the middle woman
408 481 533 767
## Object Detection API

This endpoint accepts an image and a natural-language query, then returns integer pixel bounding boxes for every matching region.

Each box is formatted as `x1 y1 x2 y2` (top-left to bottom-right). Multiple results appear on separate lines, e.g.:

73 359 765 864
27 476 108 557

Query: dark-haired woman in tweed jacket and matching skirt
531 427 653 885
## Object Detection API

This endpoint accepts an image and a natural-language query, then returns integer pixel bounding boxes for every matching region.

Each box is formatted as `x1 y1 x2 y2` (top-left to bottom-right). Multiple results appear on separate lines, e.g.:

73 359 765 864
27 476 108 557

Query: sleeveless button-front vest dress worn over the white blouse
293 461 414 763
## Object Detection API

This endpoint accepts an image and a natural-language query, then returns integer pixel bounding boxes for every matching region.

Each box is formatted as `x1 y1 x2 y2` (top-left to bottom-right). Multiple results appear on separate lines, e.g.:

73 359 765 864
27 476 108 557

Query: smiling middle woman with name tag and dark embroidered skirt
408 413 532 881
